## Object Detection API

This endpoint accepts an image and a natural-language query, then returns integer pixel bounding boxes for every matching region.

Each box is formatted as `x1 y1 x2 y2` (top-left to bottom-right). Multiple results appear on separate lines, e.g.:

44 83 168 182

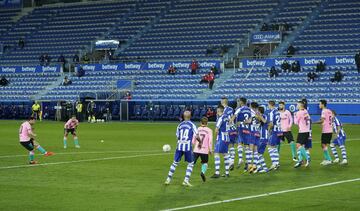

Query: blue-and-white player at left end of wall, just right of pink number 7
211 105 230 178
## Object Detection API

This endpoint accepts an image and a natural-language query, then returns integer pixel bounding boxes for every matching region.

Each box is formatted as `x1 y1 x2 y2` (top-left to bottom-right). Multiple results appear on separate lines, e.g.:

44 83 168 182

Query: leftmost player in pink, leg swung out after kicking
19 117 54 164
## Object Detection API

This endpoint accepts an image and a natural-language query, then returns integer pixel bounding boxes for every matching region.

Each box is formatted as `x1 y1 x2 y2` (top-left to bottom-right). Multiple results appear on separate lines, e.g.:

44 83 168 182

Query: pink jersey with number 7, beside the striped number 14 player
192 126 213 154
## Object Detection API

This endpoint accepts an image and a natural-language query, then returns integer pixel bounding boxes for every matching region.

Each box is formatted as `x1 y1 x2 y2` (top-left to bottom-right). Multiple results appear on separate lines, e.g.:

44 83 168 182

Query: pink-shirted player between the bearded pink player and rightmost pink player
294 101 311 168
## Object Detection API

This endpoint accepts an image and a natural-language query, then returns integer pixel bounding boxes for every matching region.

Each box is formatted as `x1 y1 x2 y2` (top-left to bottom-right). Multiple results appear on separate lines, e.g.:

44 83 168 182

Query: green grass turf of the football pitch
0 121 360 210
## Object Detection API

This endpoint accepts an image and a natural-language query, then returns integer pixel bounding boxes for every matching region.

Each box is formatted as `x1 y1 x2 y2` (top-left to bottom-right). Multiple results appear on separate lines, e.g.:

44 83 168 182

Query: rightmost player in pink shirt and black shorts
316 100 334 166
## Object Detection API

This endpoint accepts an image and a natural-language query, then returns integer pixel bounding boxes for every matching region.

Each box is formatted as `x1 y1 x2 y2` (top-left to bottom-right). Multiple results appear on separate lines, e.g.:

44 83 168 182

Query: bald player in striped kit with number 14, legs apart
165 111 200 187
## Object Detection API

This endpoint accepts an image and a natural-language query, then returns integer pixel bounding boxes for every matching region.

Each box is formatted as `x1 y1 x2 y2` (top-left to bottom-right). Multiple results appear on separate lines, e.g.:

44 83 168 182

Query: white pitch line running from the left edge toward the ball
0 153 168 170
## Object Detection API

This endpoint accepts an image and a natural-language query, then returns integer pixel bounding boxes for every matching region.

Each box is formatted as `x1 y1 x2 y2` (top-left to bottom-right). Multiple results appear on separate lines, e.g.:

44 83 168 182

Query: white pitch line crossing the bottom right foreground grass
163 178 360 211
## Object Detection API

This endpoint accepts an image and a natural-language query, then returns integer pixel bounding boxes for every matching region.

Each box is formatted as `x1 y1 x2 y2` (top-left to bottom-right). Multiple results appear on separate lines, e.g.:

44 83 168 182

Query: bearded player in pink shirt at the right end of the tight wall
279 101 297 161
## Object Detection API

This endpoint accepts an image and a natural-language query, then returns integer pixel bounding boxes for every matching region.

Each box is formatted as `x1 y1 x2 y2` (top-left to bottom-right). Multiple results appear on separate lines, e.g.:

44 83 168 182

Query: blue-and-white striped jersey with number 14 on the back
176 121 197 152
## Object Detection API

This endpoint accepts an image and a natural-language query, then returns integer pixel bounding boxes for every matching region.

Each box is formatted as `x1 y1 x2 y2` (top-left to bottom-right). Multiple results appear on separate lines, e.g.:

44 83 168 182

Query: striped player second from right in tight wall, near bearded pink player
254 106 269 173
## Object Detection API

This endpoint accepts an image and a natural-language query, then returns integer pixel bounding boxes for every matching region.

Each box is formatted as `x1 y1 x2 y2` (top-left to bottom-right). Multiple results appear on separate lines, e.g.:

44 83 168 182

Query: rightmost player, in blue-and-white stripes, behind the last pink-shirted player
330 111 347 165
